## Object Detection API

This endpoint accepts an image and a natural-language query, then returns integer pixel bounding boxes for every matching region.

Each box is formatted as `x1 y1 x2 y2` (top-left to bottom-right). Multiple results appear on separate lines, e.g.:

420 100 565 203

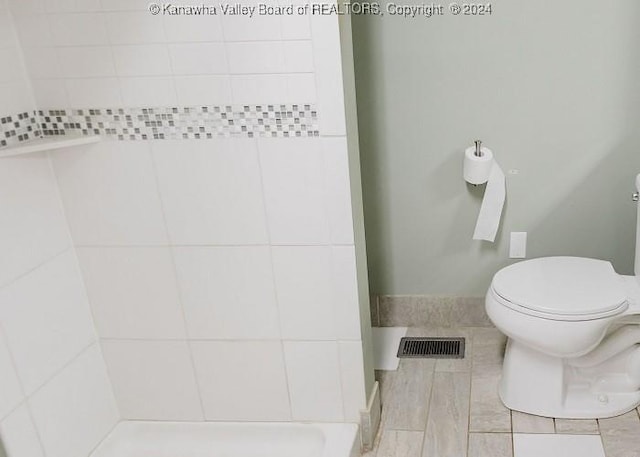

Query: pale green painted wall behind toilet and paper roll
353 0 640 296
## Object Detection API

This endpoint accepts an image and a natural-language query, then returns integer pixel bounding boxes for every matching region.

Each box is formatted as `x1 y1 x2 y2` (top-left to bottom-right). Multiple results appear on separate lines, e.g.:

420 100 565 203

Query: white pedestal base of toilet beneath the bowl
498 339 640 419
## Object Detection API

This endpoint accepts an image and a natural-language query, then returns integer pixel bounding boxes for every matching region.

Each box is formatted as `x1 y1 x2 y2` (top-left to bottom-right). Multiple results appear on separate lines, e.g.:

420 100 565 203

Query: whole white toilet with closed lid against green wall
486 175 640 419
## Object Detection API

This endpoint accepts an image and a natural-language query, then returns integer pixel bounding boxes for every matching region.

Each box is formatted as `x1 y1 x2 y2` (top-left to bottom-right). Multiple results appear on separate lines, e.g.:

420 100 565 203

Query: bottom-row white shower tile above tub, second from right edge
284 341 344 422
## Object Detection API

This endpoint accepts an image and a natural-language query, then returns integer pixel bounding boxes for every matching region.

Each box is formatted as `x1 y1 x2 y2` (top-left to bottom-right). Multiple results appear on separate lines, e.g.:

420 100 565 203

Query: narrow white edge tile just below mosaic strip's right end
320 137 354 244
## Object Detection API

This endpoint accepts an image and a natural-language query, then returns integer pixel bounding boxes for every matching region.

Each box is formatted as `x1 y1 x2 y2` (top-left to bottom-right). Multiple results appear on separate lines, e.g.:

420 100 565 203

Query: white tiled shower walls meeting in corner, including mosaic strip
0 0 373 457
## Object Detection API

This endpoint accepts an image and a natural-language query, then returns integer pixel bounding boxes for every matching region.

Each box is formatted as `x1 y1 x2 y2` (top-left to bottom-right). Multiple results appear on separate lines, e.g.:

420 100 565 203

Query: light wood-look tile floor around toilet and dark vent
364 327 640 457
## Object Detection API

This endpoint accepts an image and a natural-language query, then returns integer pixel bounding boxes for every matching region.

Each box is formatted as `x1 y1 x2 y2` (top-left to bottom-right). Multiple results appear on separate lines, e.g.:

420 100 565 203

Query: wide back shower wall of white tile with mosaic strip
2 0 373 442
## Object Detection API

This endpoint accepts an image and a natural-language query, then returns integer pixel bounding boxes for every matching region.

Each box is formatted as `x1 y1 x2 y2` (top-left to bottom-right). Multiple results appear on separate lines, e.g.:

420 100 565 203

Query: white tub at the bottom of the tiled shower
90 421 360 457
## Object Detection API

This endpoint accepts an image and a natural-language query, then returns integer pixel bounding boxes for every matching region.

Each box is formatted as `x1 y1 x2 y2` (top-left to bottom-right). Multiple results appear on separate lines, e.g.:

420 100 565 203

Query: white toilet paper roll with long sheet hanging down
463 147 506 242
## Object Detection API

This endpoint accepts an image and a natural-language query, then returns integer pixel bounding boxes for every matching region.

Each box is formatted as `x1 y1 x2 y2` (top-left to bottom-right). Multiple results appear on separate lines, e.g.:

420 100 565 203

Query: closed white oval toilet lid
491 257 626 318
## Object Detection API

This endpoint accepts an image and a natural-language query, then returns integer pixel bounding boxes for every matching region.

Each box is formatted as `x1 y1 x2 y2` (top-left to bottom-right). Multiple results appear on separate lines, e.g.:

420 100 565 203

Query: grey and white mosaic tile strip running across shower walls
0 103 320 148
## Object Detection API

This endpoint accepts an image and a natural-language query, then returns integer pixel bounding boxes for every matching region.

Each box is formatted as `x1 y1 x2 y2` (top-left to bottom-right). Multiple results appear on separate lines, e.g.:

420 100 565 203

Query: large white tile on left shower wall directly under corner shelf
0 154 71 284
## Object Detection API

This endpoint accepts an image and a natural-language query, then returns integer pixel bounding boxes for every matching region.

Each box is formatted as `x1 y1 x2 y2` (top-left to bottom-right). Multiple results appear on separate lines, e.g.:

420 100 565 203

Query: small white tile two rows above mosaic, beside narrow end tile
226 41 285 74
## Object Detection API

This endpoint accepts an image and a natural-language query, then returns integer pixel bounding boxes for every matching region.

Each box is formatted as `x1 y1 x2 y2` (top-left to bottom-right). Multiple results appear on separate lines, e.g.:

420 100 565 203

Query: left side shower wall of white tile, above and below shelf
0 2 119 457
